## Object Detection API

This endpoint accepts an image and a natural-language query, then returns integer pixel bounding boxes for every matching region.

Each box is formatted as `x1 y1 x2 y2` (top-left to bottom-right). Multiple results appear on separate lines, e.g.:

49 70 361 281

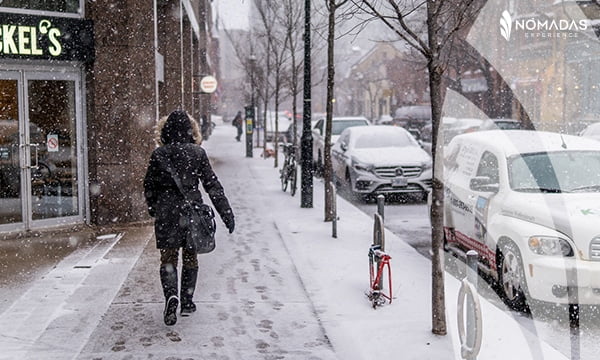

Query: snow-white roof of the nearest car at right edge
453 130 600 157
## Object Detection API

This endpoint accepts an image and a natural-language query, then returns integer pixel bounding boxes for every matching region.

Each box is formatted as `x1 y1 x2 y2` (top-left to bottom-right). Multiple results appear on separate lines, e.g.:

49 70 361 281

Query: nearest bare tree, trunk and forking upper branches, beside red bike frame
353 0 482 335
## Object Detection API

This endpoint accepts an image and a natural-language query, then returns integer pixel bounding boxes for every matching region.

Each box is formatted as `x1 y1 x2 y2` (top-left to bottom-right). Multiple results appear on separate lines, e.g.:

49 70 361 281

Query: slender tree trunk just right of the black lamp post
323 0 336 221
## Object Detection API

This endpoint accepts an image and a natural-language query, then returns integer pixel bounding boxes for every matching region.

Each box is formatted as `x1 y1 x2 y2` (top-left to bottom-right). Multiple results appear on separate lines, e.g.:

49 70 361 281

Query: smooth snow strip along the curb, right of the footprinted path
220 124 566 360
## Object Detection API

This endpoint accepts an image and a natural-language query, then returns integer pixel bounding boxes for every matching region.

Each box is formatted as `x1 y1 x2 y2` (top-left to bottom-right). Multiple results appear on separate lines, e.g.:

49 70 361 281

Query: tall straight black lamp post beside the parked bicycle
300 0 313 208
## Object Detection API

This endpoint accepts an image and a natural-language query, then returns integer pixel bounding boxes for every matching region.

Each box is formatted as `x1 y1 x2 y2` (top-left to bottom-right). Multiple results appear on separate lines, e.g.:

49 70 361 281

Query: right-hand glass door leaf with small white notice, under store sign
25 73 81 225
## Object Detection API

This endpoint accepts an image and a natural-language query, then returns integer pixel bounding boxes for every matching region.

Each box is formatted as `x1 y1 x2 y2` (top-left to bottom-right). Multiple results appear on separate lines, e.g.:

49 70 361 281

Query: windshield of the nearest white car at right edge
508 151 600 193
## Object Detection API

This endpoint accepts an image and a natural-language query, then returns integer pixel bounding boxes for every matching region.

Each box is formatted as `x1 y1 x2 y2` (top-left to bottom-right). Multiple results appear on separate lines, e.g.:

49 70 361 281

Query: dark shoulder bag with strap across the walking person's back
167 150 217 254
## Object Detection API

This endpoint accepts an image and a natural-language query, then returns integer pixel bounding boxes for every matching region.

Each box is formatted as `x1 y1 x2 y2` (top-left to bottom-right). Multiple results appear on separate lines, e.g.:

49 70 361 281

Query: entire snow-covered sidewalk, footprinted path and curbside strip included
0 125 576 360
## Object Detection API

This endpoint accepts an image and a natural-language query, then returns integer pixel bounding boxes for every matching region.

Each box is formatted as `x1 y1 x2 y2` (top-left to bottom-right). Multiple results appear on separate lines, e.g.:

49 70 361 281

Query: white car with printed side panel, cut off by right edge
444 130 600 310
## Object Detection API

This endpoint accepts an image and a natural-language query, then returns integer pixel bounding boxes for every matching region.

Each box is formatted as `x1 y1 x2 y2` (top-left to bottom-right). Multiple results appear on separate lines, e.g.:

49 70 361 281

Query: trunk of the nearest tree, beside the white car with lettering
427 0 447 335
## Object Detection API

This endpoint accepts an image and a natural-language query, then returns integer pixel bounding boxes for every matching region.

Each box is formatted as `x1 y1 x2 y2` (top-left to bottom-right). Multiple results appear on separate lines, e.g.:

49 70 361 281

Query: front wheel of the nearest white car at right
497 241 527 311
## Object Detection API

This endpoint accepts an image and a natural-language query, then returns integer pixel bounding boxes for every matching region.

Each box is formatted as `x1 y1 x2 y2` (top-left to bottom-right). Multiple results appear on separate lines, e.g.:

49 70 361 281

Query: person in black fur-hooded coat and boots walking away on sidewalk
144 110 235 325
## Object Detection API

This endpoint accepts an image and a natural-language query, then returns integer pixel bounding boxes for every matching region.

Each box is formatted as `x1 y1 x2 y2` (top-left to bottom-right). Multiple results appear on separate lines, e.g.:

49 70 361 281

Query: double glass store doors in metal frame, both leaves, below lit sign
0 70 84 231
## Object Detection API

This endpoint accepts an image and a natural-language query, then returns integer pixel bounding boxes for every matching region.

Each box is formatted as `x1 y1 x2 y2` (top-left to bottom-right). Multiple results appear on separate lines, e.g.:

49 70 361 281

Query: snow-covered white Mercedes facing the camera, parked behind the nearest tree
331 126 432 199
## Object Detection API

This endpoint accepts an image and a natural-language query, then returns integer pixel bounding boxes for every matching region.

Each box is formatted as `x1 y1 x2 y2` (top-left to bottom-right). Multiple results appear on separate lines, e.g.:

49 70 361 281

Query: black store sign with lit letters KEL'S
0 13 94 62
